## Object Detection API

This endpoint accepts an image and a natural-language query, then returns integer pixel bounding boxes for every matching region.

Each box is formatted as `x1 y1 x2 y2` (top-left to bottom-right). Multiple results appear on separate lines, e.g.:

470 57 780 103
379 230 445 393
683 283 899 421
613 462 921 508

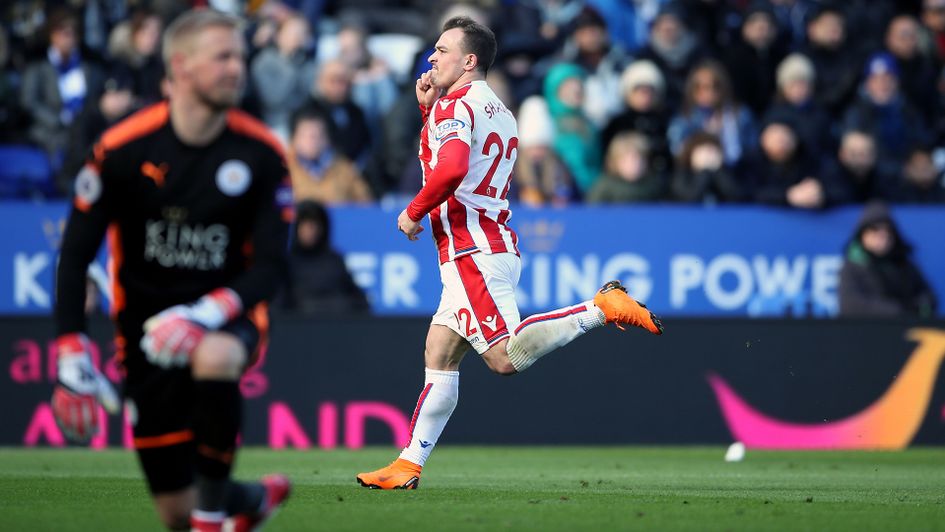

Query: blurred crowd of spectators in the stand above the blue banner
0 0 945 209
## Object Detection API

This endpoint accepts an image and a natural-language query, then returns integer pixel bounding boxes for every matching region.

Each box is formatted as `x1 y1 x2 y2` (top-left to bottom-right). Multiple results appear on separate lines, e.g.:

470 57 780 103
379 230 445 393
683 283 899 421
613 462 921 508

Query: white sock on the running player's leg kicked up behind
505 300 606 373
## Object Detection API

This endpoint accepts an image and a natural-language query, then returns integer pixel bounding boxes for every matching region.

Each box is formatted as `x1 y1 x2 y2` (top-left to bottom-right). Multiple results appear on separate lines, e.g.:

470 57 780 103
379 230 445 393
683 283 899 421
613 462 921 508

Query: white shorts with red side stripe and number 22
432 253 522 355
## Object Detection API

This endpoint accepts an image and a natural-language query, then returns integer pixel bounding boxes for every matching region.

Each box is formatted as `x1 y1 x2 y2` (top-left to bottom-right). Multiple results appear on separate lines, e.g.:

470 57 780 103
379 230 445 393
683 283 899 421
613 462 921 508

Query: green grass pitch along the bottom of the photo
0 445 945 532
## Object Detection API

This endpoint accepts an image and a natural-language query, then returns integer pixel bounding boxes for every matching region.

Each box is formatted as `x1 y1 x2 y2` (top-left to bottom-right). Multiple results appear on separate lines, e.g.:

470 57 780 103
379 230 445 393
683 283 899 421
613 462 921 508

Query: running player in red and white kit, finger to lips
356 17 663 489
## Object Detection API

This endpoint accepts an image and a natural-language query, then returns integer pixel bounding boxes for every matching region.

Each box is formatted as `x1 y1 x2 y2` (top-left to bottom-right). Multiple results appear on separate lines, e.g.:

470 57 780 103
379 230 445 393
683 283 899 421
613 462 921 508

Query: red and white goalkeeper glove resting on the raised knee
141 288 243 368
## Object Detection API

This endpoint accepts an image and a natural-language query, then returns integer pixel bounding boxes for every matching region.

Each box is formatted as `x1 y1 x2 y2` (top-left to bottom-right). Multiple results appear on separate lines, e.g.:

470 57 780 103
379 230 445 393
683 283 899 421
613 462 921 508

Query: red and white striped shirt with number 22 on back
407 81 519 263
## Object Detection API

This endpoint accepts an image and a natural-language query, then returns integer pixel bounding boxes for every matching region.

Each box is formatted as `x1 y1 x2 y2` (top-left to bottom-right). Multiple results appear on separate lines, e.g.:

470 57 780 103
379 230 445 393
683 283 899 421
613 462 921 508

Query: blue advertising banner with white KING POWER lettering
0 202 945 317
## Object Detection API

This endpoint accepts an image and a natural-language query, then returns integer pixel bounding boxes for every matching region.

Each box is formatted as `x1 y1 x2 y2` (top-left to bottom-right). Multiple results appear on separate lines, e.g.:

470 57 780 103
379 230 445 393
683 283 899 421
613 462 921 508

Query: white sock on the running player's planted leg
400 368 459 466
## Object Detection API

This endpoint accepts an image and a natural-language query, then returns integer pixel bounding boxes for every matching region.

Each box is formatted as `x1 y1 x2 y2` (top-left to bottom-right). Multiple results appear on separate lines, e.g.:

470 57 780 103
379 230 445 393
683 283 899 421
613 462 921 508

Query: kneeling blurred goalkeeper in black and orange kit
53 10 291 530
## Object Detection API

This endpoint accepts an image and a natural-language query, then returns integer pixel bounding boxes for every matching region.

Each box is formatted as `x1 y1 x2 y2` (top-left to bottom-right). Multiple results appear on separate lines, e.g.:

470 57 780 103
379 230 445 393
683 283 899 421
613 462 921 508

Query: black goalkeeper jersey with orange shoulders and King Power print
55 102 292 334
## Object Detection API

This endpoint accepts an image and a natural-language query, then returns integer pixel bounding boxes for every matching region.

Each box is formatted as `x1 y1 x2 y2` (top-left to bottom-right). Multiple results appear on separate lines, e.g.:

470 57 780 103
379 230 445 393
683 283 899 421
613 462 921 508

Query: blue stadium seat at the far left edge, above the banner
0 144 56 199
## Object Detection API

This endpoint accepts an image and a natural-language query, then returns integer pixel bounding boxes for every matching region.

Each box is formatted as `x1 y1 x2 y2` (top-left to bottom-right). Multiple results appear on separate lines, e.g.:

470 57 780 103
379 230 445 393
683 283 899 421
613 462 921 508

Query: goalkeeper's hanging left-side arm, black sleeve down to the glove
52 147 118 442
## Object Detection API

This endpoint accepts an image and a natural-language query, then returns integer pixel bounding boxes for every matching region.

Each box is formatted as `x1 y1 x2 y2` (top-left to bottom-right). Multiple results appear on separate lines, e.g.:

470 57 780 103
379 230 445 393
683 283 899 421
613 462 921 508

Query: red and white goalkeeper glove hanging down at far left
52 333 119 443
